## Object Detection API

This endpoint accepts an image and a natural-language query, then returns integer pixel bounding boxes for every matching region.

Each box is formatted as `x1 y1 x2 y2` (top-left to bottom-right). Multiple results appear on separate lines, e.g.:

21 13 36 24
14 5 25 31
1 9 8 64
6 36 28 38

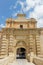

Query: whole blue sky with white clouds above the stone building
0 0 43 28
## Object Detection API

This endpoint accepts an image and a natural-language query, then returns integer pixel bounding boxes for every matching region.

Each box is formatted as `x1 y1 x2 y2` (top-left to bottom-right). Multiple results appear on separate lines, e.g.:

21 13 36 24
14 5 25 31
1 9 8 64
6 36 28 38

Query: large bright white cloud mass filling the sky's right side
26 0 43 27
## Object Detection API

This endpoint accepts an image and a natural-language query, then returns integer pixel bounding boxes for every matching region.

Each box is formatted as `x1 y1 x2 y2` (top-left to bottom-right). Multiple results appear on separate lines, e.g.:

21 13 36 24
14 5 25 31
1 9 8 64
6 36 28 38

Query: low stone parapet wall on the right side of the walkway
27 52 43 65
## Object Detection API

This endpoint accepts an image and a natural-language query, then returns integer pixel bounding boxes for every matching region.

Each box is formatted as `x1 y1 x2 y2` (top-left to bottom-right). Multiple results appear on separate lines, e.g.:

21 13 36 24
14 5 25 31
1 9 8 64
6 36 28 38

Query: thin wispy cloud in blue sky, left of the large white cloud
10 0 24 17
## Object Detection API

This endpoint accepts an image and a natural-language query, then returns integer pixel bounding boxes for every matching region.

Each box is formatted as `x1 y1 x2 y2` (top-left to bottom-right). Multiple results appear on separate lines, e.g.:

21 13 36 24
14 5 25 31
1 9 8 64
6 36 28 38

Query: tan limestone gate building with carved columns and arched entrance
0 14 43 59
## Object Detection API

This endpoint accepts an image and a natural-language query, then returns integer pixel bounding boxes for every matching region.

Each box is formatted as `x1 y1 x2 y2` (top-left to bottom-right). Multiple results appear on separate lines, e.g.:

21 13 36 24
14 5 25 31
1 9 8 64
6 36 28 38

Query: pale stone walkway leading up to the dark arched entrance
9 59 35 65
